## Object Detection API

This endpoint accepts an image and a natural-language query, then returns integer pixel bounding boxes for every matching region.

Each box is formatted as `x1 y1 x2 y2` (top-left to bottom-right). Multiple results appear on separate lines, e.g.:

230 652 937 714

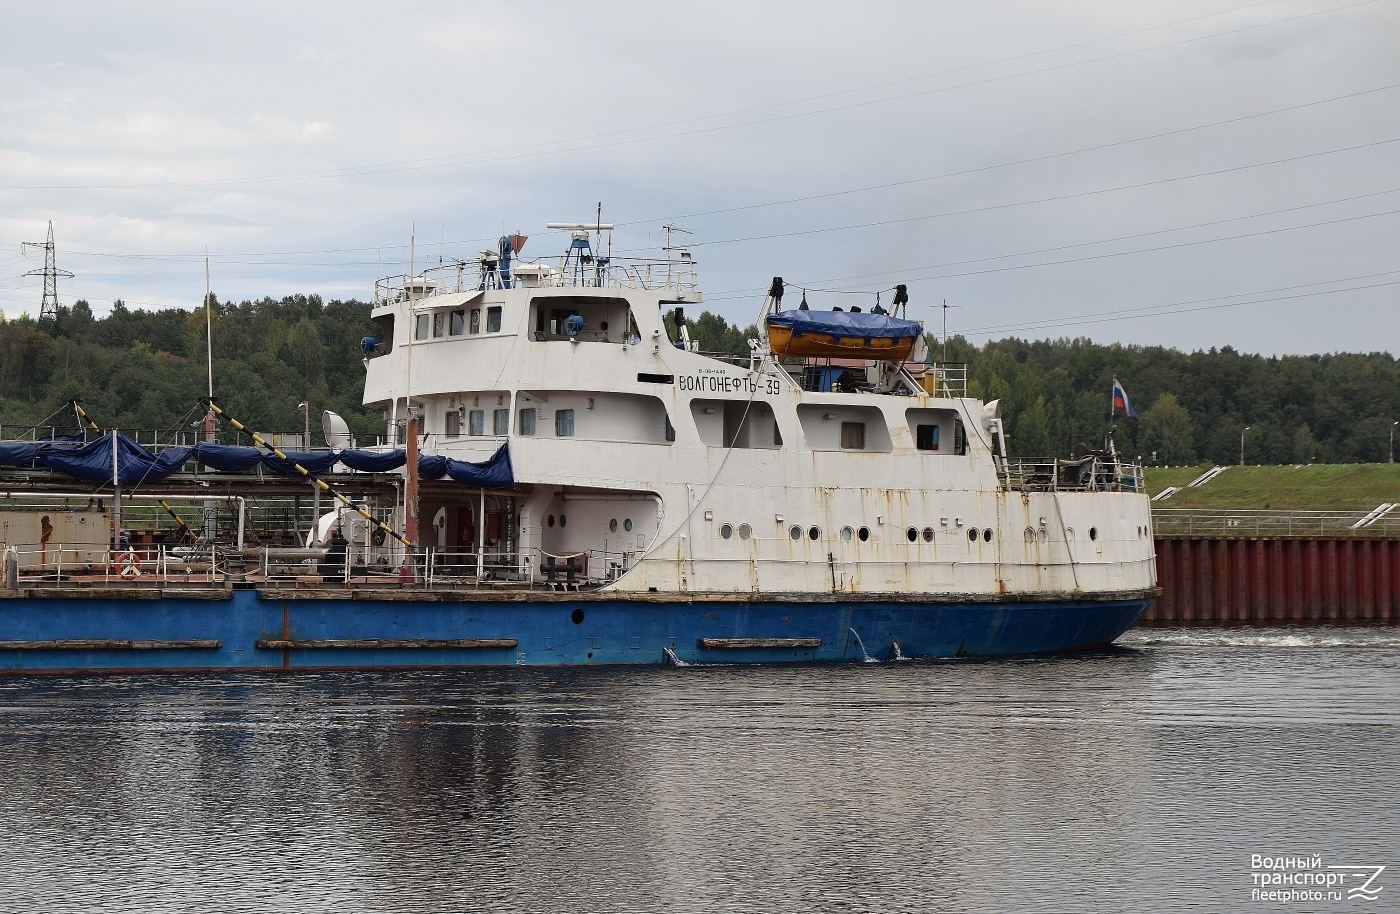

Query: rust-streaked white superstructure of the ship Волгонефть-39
364 224 1155 600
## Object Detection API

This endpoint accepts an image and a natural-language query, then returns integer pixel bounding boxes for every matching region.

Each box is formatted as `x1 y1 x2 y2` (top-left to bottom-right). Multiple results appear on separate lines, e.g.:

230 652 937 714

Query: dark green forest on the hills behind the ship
0 295 1400 466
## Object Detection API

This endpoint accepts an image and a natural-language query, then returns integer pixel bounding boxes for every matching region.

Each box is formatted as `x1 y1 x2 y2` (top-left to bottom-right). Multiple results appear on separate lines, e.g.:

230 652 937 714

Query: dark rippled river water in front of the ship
0 628 1400 913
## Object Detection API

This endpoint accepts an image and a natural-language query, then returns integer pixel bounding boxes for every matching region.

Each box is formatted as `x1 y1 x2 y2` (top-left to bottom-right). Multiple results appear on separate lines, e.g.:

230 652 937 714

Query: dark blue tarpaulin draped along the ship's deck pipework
0 434 515 488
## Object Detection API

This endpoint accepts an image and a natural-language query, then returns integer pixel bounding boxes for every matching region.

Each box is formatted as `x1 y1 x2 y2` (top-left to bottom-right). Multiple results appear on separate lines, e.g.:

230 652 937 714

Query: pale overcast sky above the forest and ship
0 0 1400 354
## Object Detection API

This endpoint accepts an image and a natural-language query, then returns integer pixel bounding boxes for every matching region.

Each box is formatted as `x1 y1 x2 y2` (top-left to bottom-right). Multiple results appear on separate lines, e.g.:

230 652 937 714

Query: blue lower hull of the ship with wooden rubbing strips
0 589 1154 673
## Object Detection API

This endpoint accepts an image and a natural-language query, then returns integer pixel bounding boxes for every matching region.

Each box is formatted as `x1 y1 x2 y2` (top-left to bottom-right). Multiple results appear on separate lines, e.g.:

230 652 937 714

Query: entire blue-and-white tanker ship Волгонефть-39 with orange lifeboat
0 223 1156 672
